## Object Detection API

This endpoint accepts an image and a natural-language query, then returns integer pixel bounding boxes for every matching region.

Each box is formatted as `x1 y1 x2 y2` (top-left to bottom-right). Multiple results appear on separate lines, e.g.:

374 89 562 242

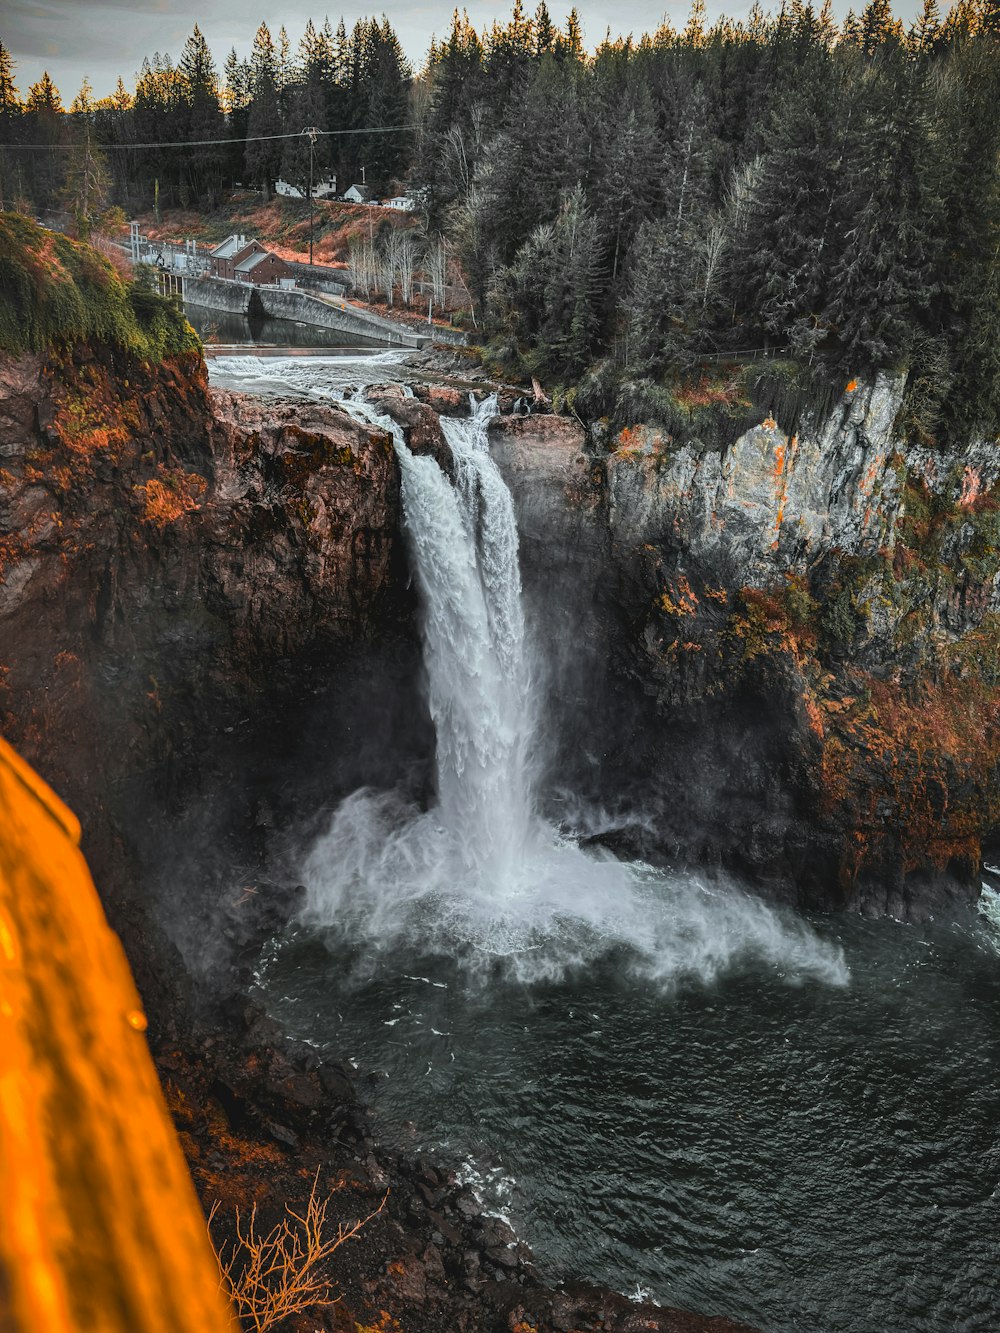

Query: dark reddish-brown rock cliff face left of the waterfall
0 348 428 1012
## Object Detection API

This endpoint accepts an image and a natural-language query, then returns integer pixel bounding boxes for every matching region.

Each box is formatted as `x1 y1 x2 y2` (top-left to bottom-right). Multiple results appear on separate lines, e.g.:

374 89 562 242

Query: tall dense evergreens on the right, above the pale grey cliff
415 0 1000 439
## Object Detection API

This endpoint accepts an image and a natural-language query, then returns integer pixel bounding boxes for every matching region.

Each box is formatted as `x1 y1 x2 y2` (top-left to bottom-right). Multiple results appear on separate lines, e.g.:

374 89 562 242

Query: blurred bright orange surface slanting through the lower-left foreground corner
0 740 237 1333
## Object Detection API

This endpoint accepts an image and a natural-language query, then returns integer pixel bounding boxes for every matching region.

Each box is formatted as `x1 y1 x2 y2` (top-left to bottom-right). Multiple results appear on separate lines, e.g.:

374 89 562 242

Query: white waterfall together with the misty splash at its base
303 389 848 986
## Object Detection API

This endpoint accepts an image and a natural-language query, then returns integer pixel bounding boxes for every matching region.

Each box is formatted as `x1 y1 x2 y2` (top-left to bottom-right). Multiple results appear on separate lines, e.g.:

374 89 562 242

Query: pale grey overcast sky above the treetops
7 0 928 105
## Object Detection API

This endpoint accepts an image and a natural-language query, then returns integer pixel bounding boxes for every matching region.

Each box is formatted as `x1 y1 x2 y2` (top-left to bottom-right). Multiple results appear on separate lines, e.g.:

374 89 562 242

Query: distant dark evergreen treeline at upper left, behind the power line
0 19 412 216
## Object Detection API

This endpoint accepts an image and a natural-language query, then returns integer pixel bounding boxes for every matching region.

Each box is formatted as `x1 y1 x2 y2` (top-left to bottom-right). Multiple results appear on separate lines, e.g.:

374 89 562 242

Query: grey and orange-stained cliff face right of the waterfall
495 379 1000 914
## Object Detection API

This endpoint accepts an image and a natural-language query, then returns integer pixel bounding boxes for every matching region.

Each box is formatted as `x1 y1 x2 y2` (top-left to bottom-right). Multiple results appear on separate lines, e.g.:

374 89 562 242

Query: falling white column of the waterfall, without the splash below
393 397 533 889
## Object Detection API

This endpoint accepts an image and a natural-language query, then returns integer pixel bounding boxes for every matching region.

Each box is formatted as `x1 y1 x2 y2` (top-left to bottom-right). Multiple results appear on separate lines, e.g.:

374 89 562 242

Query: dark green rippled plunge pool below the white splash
261 901 1000 1333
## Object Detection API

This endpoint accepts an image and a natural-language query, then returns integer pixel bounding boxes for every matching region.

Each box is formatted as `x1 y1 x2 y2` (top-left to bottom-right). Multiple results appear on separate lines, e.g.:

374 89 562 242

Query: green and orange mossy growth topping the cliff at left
0 213 201 361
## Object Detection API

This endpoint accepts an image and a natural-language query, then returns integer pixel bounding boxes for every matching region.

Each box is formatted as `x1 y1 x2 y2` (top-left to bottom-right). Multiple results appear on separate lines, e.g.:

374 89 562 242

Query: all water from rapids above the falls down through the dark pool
211 357 1000 1333
